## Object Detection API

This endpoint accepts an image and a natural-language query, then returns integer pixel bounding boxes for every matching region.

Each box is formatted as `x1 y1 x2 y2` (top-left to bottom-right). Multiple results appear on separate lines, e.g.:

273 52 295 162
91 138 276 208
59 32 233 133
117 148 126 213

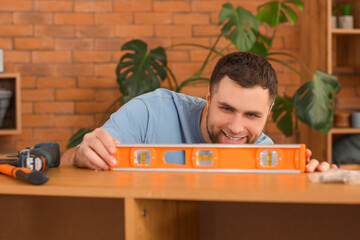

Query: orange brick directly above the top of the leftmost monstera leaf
115 25 154 38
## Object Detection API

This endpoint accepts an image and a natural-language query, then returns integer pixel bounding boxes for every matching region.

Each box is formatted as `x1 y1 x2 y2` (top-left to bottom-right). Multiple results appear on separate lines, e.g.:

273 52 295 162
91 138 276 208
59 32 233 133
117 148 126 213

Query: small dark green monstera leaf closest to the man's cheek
272 95 294 137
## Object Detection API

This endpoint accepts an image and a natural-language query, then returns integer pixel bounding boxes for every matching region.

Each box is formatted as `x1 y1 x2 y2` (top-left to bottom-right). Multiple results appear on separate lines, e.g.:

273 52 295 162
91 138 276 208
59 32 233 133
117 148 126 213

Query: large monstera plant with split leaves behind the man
67 0 340 148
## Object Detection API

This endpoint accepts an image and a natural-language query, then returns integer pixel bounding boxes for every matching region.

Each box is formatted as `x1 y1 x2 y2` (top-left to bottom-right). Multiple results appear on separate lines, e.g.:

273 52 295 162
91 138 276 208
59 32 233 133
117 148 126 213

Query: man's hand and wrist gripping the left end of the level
61 128 119 170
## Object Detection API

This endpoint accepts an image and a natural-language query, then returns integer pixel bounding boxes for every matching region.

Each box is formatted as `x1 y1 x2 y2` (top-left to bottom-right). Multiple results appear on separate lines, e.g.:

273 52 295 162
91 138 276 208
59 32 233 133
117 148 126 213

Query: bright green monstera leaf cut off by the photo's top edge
256 0 304 27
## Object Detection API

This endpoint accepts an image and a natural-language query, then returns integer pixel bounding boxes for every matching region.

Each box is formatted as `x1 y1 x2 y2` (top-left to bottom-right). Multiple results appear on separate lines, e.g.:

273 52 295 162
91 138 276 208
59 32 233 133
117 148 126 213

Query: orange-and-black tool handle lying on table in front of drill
0 164 49 185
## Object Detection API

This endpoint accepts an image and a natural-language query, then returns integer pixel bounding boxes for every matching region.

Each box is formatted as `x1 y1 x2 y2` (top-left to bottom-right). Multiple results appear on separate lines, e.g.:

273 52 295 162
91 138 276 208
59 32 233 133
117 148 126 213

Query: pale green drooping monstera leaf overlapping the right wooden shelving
294 71 341 130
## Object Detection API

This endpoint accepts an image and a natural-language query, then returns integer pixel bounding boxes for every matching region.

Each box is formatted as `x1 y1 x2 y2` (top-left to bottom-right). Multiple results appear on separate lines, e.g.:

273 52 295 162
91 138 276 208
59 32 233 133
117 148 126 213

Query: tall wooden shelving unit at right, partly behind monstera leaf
300 0 360 163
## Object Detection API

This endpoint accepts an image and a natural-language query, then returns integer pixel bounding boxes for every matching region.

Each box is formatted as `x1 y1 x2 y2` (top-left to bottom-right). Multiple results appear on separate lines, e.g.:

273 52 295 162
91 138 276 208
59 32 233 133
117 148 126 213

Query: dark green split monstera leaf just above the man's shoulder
116 39 167 104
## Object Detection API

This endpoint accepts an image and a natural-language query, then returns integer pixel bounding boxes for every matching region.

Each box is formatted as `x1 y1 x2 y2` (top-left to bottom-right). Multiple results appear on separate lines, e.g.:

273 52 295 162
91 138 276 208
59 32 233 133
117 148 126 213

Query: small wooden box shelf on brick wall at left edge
0 73 21 135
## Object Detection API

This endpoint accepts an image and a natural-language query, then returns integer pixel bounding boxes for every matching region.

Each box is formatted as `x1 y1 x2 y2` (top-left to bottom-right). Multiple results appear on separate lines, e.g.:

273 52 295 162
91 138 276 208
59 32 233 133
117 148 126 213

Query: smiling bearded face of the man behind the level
202 75 272 144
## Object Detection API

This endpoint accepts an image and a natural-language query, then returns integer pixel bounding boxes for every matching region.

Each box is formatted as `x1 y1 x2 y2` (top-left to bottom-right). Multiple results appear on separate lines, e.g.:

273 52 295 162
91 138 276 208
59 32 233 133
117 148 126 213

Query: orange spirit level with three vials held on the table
111 144 306 173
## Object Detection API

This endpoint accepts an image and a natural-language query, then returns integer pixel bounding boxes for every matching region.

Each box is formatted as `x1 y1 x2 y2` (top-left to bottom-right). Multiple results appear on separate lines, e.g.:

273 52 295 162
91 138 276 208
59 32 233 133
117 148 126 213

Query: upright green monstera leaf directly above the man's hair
219 3 258 51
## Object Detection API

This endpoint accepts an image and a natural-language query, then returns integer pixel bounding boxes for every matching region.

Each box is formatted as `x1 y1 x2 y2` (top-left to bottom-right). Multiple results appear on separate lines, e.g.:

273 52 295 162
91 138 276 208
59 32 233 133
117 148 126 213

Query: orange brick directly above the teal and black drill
33 128 73 141
